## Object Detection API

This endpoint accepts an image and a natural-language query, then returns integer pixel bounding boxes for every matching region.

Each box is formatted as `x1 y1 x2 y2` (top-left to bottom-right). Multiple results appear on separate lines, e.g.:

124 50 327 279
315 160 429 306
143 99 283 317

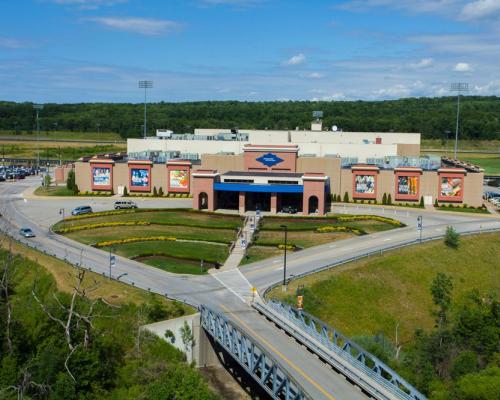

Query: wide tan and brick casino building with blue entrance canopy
75 121 483 215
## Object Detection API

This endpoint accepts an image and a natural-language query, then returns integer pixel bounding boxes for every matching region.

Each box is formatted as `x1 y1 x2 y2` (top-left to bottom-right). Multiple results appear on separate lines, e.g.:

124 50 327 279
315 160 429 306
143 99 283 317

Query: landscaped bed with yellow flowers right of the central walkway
242 214 405 264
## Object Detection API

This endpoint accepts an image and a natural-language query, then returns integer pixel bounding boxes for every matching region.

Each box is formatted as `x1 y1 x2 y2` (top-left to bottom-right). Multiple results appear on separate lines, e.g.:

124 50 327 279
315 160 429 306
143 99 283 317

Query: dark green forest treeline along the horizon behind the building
0 96 500 140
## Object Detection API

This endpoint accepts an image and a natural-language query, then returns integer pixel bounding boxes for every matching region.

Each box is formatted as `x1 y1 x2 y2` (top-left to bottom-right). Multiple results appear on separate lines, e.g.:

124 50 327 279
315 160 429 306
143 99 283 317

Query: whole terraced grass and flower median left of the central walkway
52 209 243 274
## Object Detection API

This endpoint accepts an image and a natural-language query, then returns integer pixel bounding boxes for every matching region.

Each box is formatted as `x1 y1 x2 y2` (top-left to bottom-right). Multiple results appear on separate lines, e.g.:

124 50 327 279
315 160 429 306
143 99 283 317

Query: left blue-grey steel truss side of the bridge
200 305 312 400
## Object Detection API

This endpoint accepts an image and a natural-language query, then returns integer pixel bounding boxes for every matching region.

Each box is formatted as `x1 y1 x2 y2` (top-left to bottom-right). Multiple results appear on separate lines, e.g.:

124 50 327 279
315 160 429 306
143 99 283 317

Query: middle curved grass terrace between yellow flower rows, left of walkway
66 225 236 245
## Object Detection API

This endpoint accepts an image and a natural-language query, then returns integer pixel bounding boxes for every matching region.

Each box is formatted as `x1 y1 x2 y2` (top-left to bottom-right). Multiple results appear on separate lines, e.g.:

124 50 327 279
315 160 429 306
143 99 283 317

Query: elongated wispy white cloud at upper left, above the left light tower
87 17 182 36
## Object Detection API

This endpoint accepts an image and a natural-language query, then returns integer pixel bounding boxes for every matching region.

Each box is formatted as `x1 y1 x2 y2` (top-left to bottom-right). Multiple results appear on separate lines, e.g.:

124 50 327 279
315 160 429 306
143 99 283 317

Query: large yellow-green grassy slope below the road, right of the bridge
269 233 500 343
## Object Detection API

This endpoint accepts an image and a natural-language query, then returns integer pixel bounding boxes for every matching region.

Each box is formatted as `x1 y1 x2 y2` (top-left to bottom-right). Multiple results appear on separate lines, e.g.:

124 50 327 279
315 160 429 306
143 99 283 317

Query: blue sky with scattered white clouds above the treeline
0 0 500 103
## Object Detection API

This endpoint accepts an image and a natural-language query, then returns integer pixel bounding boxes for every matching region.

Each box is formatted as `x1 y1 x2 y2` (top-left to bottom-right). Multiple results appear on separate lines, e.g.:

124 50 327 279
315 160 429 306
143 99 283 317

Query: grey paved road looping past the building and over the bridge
0 178 500 400
